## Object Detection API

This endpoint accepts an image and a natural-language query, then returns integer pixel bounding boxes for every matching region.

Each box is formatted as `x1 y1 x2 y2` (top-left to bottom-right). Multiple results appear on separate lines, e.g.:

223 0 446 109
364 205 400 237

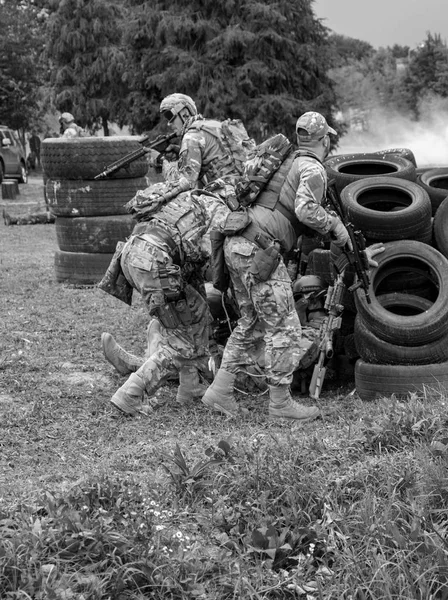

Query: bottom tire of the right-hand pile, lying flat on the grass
355 359 448 401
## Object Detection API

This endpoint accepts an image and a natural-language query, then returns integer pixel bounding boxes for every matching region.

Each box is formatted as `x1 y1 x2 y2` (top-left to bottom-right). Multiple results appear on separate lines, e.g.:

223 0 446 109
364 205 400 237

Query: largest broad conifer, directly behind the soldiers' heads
121 0 335 138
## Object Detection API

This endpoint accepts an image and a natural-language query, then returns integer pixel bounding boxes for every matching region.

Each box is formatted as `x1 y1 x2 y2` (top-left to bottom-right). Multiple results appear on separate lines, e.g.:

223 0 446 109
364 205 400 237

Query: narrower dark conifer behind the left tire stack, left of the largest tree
47 0 131 135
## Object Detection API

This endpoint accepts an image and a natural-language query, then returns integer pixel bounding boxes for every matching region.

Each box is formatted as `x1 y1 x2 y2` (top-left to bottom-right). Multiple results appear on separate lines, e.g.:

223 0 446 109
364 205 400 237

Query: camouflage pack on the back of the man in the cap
235 133 293 206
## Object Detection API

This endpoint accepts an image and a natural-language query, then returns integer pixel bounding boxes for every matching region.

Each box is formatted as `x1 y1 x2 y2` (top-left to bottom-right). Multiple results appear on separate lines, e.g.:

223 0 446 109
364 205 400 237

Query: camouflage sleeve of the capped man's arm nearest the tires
294 163 333 235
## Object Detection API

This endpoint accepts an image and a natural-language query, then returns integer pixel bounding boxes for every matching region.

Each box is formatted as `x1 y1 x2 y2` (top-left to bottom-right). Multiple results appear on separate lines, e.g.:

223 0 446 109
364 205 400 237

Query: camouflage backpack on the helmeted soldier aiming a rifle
189 119 256 175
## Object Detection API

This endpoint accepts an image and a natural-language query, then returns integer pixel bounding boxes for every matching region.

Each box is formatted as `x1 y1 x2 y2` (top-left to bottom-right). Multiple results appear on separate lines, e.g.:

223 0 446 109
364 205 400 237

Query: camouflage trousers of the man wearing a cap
221 236 309 385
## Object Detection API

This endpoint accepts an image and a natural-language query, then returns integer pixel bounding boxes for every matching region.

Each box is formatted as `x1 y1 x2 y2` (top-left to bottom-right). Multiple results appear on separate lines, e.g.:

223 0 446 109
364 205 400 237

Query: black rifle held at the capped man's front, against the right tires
327 183 371 304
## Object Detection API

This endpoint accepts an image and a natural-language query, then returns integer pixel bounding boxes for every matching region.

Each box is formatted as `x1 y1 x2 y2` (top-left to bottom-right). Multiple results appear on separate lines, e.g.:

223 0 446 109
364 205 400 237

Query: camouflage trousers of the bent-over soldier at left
121 234 211 370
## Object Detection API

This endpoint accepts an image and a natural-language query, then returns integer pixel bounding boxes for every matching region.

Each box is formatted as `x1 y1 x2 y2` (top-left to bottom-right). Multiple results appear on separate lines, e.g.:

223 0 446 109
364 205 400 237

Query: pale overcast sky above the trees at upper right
313 0 448 48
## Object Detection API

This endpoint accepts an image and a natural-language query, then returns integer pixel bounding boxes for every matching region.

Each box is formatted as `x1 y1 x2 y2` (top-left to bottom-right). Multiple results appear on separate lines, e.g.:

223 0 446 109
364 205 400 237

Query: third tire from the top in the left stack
55 215 136 254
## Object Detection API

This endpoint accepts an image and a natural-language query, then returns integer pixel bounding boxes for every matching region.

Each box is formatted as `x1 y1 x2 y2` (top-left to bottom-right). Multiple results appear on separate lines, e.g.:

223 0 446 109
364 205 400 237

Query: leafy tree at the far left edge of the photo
0 0 48 141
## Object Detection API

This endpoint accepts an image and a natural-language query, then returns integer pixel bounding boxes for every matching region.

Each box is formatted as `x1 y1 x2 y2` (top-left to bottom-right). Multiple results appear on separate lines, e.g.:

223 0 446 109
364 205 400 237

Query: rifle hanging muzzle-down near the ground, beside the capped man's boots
309 271 345 400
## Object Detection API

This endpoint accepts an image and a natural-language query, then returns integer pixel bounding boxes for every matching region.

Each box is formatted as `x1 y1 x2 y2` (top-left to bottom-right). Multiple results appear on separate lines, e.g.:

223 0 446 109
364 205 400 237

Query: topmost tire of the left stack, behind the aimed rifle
41 136 148 179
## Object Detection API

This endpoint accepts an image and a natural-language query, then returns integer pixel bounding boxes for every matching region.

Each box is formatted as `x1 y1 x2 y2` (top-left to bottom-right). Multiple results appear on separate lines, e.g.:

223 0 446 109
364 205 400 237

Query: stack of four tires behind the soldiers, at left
41 136 148 285
